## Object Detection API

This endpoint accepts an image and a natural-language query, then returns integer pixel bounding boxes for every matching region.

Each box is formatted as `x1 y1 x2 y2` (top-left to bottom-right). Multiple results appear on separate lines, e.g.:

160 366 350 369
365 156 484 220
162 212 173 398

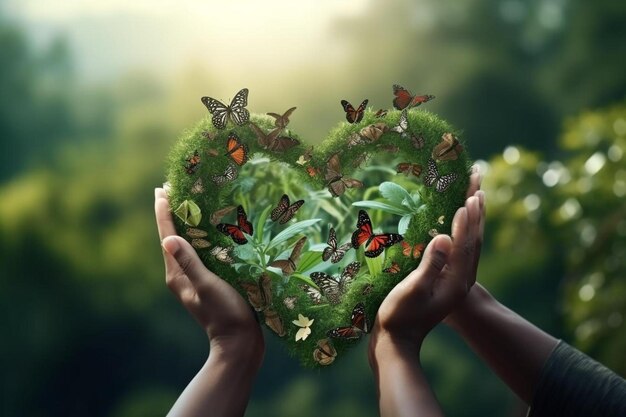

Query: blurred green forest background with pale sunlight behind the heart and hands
0 0 626 417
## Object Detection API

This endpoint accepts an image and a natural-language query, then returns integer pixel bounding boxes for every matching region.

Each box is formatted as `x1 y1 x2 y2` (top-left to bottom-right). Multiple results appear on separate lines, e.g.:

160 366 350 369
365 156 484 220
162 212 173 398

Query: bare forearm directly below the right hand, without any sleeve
370 339 443 417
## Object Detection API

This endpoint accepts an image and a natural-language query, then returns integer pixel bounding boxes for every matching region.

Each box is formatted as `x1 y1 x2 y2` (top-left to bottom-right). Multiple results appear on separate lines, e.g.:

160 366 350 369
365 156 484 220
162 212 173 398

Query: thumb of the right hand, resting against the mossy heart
404 234 452 292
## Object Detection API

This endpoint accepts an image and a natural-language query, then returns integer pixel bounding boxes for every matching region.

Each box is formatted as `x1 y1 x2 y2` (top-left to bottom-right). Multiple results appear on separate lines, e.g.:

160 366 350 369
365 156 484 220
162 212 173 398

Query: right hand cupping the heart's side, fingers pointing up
370 167 485 352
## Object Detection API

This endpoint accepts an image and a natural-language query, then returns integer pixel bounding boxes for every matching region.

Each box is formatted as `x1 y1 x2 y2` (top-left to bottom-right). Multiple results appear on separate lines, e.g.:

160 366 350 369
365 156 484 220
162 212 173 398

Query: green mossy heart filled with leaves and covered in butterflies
167 91 469 367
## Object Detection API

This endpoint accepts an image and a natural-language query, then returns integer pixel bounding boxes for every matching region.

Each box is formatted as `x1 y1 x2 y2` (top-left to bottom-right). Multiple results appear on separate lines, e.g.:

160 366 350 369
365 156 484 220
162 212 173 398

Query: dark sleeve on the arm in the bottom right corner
528 341 626 417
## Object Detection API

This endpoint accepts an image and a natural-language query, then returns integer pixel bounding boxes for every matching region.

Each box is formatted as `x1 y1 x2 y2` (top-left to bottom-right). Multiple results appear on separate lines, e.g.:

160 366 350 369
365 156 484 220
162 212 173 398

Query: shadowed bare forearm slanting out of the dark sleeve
446 284 558 404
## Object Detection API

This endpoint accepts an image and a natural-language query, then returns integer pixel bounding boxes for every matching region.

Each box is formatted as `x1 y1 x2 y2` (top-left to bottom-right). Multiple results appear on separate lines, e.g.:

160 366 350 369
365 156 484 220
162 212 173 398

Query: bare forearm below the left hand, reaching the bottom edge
168 342 263 417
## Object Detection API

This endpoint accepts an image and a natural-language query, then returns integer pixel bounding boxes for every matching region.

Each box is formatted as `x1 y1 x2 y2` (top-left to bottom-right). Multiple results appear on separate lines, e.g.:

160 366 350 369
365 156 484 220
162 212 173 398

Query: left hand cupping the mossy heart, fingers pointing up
154 188 265 363
